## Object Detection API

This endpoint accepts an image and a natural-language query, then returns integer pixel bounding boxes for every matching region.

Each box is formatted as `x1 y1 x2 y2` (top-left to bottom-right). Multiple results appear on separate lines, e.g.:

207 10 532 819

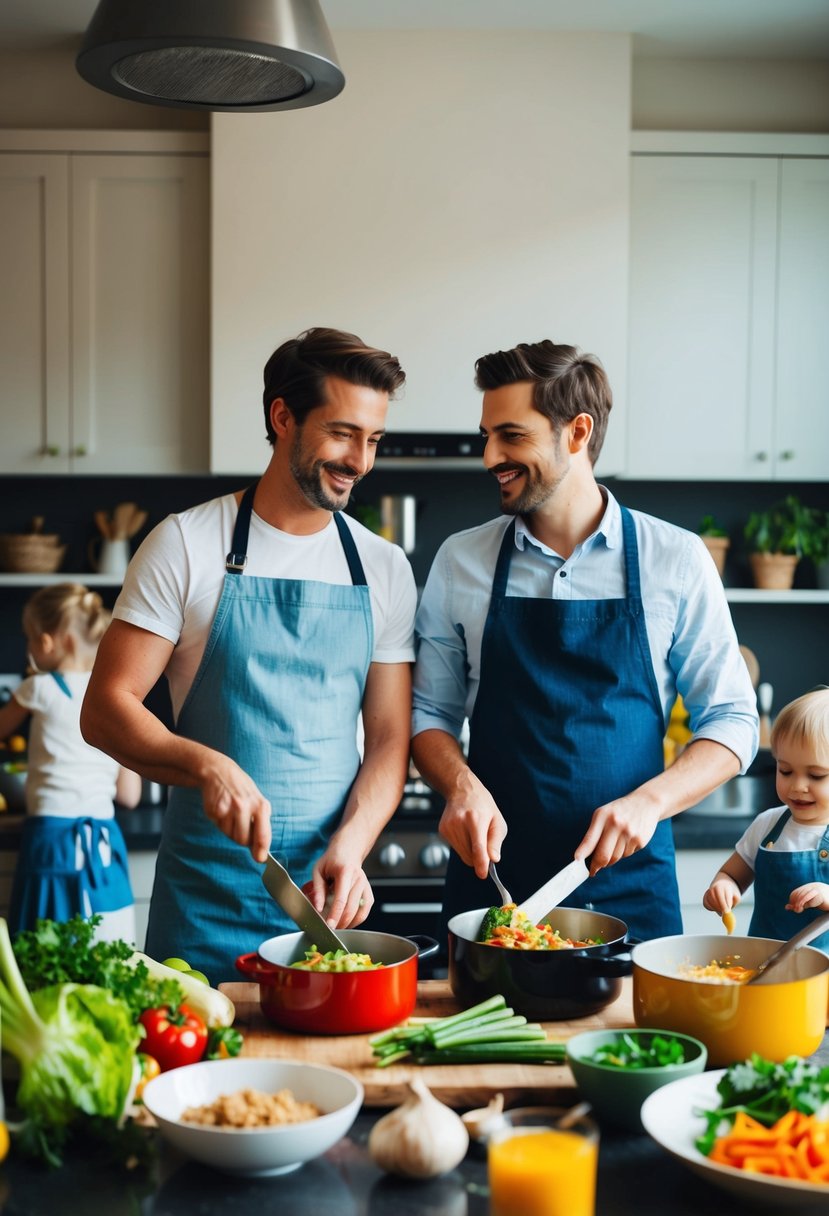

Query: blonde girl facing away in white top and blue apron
0 582 141 941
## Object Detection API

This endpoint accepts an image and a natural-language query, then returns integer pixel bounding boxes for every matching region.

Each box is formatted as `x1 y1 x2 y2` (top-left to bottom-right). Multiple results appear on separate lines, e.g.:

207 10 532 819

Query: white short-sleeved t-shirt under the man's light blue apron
113 494 417 719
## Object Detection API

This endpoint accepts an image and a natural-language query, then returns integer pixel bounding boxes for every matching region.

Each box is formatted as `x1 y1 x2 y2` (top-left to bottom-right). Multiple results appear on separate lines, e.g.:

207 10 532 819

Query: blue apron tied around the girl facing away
9 671 134 935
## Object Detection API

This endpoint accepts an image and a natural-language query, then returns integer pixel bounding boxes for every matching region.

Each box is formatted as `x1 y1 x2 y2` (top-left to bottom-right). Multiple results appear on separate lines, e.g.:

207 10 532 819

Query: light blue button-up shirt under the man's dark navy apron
412 486 758 772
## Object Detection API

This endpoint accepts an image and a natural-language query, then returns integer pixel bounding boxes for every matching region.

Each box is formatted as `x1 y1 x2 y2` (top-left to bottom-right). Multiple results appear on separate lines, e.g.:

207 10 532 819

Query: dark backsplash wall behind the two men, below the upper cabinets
0 463 829 713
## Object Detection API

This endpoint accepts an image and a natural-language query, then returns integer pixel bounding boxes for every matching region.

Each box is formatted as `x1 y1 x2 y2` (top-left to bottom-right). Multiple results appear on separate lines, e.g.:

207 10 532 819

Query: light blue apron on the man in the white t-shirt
147 485 373 984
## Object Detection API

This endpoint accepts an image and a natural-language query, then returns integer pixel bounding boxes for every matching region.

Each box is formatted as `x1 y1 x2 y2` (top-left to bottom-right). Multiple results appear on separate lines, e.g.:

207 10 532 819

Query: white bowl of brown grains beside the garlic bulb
143 1058 363 1177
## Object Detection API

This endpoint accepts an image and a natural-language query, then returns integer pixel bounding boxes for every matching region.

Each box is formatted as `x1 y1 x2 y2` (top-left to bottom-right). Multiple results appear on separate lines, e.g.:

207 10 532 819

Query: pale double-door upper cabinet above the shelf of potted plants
625 136 829 482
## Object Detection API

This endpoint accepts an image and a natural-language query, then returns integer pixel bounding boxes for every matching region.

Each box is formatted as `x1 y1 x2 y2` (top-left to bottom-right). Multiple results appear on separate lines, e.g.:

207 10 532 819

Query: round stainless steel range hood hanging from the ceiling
75 0 337 113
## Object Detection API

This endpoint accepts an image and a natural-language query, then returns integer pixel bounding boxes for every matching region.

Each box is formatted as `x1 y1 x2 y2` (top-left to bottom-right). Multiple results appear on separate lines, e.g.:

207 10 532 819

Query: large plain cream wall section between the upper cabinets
212 32 630 472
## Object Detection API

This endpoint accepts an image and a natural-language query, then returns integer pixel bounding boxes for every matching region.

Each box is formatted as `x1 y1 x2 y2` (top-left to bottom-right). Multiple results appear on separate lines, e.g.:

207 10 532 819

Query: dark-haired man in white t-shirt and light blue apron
81 328 416 983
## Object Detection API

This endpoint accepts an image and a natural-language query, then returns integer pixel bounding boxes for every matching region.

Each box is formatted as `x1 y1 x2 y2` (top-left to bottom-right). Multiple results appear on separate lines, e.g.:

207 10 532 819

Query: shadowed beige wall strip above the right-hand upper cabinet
632 58 829 134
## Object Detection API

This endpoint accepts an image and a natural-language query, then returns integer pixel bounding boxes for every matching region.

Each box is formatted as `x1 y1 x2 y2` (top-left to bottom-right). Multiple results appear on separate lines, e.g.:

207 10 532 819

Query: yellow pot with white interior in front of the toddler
631 934 829 1068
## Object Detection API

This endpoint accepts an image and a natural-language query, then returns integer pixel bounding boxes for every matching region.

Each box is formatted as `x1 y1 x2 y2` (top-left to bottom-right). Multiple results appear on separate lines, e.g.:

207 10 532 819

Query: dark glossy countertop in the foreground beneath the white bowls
0 1021 829 1216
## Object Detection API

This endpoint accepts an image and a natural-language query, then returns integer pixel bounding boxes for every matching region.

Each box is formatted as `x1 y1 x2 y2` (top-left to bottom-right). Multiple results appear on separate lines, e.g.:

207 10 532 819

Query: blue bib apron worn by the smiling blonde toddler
749 810 829 952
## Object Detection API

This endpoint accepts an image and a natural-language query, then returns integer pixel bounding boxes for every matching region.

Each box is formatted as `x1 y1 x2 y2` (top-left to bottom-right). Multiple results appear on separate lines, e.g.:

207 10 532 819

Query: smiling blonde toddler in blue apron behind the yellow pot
703 687 829 951
